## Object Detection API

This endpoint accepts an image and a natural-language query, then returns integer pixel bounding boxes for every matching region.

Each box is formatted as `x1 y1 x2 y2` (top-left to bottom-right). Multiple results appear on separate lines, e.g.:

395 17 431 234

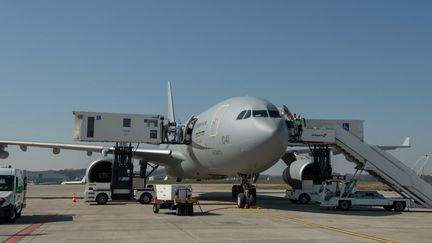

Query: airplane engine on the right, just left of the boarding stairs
282 160 313 189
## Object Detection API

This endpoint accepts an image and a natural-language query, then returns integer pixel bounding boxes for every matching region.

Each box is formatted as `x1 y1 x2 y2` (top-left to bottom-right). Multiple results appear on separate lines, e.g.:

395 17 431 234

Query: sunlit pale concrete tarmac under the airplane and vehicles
0 184 432 243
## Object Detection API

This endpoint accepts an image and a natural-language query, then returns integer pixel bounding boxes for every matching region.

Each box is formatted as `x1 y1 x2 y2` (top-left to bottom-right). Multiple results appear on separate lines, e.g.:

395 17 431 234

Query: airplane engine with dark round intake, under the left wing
85 158 113 183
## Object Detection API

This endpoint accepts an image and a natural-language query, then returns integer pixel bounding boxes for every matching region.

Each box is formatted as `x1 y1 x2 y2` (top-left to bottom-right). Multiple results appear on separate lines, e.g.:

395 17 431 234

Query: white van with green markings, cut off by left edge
0 166 27 223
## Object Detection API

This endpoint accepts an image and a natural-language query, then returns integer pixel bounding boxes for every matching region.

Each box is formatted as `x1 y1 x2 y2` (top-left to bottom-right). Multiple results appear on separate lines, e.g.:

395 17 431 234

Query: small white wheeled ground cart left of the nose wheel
152 185 198 216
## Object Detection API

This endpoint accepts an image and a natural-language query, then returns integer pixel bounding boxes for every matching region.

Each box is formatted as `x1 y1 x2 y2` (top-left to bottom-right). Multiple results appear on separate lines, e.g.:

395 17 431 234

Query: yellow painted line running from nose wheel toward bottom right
254 210 395 243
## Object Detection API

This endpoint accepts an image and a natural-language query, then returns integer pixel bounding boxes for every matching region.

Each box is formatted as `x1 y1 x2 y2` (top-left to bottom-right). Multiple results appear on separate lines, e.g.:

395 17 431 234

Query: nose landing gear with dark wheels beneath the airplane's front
232 175 258 208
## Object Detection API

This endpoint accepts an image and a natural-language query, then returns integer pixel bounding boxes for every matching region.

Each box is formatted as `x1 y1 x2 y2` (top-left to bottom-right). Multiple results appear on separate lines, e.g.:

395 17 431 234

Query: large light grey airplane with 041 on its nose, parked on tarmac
0 83 289 207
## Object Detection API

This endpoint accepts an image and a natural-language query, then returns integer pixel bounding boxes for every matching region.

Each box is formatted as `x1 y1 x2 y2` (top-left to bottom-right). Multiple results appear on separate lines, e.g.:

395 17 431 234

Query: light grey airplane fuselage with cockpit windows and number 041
160 96 288 179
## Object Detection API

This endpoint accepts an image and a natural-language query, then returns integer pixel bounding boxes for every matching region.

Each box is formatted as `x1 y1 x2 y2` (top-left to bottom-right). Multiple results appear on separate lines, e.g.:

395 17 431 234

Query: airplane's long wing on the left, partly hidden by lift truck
0 140 180 166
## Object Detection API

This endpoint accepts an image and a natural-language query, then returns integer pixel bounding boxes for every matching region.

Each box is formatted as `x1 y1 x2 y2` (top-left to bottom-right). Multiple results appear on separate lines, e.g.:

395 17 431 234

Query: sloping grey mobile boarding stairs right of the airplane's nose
291 119 432 207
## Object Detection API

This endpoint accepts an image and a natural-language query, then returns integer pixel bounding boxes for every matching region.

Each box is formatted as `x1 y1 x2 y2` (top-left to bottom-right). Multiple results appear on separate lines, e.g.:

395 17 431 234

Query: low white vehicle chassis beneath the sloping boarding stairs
319 178 410 212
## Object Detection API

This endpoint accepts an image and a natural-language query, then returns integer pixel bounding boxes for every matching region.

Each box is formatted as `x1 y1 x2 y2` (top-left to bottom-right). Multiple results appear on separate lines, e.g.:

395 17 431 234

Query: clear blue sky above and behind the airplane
0 0 432 174
